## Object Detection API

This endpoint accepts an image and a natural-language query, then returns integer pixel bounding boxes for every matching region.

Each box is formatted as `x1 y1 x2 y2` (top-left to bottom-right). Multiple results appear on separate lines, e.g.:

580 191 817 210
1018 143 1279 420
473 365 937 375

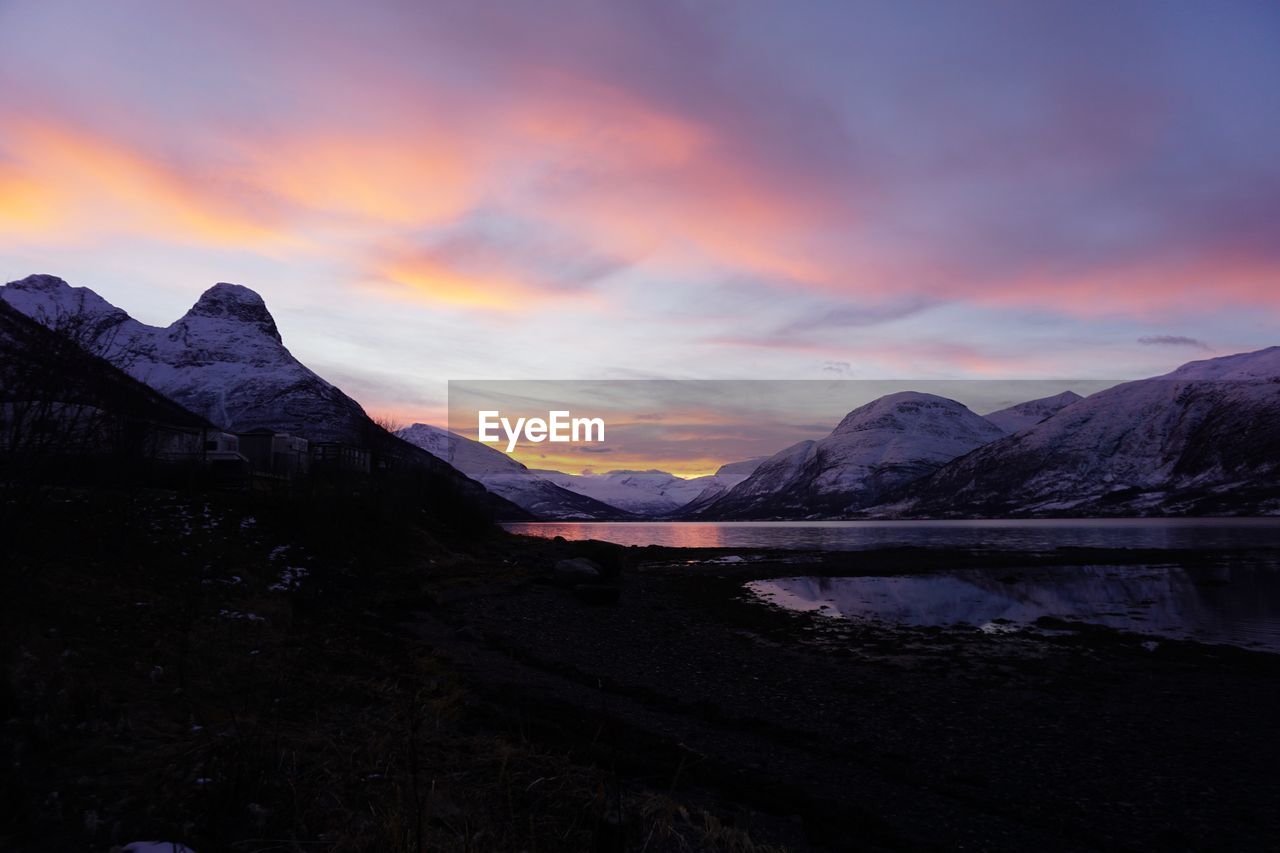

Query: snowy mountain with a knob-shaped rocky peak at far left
0 275 370 443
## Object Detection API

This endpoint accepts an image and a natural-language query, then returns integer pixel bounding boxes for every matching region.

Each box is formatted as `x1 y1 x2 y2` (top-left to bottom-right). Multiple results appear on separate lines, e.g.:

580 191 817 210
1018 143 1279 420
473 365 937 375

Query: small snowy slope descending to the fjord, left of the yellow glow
396 424 627 520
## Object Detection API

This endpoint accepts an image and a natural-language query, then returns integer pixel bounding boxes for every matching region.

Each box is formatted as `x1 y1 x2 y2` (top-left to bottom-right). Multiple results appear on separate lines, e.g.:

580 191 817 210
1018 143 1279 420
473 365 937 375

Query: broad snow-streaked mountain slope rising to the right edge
883 347 1280 516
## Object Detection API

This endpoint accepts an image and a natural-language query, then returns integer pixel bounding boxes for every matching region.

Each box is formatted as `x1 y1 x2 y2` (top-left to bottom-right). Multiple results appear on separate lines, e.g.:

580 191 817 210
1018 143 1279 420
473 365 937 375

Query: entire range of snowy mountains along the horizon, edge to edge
0 275 1280 520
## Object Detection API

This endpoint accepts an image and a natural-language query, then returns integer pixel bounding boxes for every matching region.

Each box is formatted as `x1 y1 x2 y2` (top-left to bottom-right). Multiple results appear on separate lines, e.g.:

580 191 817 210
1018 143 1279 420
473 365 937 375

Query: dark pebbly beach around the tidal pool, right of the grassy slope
419 540 1280 850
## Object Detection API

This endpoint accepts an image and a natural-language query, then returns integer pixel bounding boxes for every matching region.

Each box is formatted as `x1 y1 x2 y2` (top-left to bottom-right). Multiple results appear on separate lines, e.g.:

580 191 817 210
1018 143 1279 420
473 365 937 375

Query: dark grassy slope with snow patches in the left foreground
0 488 788 853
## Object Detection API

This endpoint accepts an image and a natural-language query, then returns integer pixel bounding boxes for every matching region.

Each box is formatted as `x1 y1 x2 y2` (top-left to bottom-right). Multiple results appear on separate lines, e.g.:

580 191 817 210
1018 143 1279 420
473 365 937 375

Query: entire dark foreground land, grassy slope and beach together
0 481 1280 853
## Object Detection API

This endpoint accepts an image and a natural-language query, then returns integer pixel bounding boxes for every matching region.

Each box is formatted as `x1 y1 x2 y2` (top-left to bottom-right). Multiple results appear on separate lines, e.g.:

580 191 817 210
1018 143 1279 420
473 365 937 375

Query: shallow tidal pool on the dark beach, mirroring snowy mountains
748 564 1280 651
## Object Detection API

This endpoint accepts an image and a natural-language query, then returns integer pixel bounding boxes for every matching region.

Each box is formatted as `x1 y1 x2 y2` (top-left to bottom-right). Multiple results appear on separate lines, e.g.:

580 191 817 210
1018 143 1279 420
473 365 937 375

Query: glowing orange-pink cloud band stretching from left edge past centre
0 74 849 310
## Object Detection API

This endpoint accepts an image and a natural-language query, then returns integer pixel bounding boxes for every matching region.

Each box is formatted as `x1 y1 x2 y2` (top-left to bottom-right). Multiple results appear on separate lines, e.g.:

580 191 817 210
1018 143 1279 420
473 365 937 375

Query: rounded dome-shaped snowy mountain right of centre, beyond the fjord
700 391 1004 519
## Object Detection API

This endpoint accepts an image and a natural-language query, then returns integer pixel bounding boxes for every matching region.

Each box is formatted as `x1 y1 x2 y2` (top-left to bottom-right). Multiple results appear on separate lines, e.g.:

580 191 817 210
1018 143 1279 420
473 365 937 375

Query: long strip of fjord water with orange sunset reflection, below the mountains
506 519 1280 551
